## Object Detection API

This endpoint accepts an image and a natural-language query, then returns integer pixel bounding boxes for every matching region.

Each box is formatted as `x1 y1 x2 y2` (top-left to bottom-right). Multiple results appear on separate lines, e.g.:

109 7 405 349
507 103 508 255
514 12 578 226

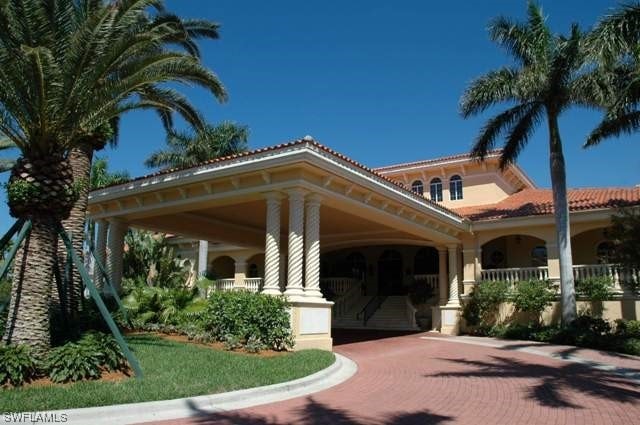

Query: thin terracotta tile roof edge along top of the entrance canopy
96 138 464 219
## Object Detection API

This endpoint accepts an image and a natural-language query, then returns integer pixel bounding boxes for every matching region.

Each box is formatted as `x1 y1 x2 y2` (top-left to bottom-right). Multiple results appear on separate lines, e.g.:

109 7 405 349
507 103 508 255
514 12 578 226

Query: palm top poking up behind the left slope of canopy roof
145 121 249 168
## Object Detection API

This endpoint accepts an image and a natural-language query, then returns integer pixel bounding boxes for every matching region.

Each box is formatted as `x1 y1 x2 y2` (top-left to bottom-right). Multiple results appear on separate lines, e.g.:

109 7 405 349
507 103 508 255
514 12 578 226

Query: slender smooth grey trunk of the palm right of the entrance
548 113 577 326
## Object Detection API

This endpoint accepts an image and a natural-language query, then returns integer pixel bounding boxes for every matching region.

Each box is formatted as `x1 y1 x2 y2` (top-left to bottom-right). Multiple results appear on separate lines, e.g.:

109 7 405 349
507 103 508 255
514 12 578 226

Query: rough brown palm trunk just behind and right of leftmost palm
54 146 93 317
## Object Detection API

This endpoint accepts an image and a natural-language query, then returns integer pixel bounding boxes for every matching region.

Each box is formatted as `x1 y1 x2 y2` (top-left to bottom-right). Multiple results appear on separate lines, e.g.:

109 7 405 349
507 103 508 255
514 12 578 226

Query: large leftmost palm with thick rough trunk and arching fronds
0 0 225 353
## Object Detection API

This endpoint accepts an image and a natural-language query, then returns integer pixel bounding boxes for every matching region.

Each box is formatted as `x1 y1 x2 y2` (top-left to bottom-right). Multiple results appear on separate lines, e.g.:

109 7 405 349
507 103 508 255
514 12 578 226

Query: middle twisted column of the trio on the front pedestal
284 189 304 297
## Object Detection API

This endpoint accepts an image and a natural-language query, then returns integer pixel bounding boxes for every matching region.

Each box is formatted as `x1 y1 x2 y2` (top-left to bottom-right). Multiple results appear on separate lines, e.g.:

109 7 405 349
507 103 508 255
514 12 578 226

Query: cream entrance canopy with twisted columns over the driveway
89 140 469 349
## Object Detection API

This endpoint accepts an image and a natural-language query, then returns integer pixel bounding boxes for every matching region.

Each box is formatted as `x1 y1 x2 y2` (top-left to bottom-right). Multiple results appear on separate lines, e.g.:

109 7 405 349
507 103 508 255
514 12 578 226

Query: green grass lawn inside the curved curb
0 334 334 412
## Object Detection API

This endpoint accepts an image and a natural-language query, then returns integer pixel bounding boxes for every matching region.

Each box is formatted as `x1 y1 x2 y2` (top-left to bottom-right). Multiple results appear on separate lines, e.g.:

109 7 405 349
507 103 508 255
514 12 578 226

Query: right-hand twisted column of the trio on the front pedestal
304 195 322 298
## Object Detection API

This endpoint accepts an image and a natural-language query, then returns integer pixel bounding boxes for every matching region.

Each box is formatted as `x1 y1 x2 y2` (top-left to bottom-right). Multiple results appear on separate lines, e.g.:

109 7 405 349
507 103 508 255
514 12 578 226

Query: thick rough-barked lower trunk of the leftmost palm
3 219 57 355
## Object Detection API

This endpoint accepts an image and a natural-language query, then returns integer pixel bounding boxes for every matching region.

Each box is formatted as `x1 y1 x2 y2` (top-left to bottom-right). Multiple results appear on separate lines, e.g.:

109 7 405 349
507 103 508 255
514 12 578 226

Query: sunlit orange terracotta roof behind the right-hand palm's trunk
454 187 640 221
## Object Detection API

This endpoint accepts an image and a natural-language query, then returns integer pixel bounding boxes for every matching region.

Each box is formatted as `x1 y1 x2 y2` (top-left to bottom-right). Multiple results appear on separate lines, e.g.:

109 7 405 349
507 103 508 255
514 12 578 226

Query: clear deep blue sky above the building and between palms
0 0 640 230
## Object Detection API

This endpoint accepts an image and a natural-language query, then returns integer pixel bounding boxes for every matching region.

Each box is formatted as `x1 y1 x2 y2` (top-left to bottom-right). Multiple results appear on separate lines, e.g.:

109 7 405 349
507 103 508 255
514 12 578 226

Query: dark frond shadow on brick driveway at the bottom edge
184 397 454 425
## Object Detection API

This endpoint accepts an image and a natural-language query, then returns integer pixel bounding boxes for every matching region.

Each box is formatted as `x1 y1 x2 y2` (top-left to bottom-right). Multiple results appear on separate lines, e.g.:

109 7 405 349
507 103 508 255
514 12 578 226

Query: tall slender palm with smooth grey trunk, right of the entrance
461 2 596 324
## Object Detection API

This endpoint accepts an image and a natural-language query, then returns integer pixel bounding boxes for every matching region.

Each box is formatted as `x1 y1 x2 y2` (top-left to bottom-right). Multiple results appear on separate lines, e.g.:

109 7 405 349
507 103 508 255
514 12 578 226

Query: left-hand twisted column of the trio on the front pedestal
262 192 282 295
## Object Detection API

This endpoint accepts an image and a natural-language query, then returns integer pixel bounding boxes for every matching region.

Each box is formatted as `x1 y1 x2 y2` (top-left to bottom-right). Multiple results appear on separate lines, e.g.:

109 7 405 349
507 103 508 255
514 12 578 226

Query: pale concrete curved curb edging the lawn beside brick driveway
44 353 358 425
